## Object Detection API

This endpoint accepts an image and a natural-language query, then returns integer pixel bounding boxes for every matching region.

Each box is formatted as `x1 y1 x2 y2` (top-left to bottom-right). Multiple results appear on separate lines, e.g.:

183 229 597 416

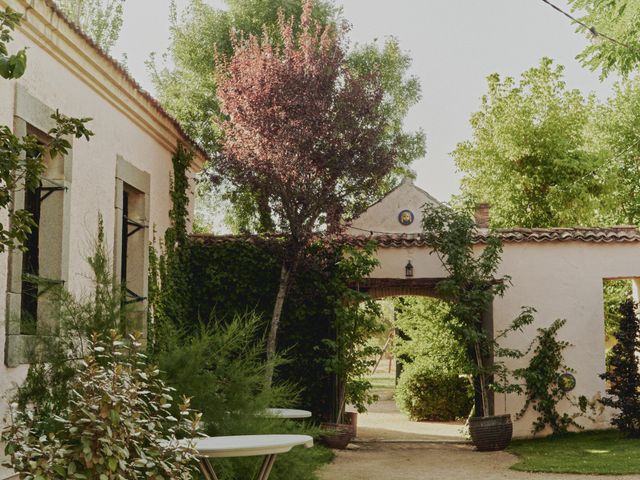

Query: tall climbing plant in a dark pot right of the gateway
423 205 533 451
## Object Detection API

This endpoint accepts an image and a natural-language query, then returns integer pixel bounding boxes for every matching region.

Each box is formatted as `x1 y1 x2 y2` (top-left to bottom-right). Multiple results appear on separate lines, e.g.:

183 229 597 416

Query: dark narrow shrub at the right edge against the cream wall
600 300 640 438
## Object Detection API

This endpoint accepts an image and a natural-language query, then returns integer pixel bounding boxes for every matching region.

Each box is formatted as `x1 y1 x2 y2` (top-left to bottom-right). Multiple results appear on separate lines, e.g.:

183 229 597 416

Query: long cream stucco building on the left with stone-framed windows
0 0 205 472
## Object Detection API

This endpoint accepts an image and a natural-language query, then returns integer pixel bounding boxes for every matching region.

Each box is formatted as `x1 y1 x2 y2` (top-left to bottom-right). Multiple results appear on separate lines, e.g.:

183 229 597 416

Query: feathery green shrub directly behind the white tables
154 315 332 480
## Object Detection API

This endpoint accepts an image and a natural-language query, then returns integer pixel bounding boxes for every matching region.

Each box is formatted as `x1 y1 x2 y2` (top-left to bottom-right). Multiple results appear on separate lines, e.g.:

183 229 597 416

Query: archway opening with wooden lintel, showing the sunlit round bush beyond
350 279 473 443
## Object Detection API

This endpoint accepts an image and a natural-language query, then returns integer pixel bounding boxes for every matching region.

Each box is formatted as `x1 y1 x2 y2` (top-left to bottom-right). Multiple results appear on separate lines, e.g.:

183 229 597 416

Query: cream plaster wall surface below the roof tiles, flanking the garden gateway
372 241 640 436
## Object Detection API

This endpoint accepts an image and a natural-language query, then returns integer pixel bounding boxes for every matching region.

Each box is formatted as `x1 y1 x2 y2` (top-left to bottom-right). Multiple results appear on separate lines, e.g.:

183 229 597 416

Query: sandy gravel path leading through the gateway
319 390 640 480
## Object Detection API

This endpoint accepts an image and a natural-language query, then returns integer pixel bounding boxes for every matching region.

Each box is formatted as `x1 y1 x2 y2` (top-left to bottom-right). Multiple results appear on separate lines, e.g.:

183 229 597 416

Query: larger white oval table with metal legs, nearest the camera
195 435 313 480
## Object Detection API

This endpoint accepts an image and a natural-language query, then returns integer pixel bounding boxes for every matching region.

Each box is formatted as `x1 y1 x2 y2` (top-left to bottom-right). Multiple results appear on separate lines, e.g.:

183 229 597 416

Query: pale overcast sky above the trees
113 0 612 201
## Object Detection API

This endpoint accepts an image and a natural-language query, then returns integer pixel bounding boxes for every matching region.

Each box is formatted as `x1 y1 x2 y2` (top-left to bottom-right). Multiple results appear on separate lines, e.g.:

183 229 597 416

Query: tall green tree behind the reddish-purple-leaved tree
149 0 425 231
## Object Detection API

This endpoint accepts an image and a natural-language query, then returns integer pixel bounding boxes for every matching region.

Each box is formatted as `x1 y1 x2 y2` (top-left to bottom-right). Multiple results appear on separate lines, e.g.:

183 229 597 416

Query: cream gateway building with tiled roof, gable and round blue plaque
348 180 640 437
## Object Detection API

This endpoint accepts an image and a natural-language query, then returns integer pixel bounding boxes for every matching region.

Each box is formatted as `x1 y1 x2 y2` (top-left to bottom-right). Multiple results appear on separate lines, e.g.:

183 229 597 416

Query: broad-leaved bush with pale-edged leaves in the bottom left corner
2 331 200 480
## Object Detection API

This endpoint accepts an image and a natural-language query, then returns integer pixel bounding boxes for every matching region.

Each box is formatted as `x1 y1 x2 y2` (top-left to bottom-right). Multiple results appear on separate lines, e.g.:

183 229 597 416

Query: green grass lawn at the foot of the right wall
509 430 640 475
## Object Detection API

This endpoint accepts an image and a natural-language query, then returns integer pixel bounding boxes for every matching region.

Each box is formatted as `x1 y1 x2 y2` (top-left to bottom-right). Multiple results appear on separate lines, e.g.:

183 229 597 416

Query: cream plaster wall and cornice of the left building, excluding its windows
0 0 200 430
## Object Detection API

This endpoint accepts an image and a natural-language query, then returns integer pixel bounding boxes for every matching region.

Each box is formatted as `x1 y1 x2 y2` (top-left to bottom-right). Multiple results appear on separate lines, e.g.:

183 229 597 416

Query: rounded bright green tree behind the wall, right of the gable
453 58 606 227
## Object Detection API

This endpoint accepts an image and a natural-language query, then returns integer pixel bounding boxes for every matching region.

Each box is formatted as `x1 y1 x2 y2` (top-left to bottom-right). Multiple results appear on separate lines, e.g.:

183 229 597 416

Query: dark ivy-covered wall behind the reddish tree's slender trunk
169 235 343 416
